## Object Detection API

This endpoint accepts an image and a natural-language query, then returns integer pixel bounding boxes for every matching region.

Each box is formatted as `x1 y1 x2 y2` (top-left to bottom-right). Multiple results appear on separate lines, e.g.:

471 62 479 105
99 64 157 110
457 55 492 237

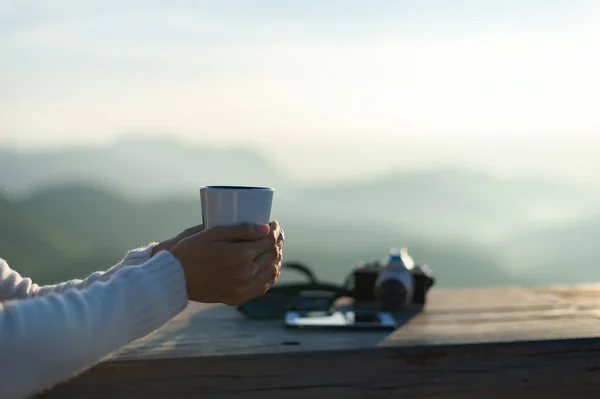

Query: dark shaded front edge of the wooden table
40 339 600 399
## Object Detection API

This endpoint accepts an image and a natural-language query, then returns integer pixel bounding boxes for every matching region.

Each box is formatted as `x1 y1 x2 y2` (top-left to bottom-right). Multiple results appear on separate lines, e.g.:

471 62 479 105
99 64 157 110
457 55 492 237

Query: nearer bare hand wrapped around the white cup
170 222 285 306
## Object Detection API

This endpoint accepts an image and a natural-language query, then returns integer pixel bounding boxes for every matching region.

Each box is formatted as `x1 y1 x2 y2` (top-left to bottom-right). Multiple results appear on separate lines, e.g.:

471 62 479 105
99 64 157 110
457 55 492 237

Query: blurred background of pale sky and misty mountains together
0 0 600 287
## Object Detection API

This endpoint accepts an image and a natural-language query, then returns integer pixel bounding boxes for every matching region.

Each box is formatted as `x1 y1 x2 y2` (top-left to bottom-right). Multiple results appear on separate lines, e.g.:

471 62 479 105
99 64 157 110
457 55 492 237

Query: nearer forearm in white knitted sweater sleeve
0 252 187 398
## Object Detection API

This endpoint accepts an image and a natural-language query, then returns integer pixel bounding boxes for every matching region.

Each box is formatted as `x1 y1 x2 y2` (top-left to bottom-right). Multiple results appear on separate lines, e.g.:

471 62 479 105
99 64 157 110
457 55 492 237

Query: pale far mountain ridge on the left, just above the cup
0 139 286 198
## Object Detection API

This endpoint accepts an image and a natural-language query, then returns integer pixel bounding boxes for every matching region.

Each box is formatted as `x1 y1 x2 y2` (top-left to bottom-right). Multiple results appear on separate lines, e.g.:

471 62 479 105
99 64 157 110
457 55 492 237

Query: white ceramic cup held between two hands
200 186 274 229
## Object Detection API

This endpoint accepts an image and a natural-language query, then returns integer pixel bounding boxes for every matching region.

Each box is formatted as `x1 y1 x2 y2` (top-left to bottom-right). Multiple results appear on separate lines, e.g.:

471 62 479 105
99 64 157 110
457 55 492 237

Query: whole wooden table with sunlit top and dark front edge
40 284 600 399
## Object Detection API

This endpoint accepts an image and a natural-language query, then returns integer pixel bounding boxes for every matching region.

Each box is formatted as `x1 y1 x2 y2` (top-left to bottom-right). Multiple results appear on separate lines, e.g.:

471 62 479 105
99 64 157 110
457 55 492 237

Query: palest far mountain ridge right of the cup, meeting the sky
286 169 600 243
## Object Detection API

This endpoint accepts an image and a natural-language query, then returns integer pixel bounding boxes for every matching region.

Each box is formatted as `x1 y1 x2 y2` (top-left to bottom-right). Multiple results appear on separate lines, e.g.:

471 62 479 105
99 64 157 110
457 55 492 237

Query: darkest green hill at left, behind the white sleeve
0 186 201 282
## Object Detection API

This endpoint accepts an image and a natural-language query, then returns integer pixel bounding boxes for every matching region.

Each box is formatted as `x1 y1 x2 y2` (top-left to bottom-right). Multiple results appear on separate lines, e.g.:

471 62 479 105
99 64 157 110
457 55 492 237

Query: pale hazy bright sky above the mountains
0 0 600 184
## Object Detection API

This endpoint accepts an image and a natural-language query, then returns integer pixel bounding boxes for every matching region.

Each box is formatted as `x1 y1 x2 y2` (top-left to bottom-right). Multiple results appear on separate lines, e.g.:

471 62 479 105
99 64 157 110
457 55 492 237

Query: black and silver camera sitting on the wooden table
350 248 435 309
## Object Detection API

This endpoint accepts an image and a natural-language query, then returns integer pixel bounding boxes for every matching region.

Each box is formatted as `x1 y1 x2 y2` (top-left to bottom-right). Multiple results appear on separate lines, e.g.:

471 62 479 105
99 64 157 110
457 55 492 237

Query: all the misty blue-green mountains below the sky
0 141 600 286
